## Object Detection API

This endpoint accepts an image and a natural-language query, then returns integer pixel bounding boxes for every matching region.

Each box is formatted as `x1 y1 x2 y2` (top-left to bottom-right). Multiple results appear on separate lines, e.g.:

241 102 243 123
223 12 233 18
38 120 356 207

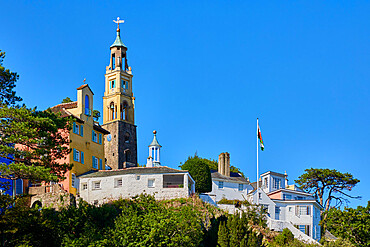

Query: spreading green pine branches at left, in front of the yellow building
0 105 71 181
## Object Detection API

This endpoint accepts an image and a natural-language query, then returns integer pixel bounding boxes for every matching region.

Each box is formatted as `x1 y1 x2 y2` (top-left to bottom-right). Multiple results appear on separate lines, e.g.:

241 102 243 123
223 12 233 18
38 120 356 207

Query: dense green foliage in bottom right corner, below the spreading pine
322 201 370 246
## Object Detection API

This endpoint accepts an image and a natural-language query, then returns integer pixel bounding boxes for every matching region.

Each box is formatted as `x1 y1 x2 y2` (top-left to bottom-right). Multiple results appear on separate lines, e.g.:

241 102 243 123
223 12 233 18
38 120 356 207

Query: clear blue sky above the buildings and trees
0 0 370 206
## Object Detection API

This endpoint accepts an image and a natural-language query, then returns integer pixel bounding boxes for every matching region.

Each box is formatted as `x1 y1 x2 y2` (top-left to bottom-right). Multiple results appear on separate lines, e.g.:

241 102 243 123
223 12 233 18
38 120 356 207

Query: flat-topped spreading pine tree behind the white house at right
295 168 360 211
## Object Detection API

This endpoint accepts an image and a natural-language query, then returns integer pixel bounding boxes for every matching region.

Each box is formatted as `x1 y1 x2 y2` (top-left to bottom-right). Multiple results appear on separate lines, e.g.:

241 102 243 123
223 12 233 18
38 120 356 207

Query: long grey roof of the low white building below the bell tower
79 166 188 178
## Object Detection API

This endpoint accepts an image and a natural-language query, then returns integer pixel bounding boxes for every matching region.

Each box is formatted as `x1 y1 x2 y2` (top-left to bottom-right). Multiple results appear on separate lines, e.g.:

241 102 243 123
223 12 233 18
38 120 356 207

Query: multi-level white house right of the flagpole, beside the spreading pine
249 171 323 240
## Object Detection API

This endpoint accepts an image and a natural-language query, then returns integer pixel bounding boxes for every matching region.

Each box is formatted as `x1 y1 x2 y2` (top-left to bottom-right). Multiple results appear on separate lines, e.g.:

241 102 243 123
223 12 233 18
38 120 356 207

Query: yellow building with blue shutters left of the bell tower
51 84 109 195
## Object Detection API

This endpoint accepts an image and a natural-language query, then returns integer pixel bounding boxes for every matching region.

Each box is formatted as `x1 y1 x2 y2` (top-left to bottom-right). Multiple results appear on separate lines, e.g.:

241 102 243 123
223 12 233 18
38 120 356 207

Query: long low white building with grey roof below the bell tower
79 166 195 205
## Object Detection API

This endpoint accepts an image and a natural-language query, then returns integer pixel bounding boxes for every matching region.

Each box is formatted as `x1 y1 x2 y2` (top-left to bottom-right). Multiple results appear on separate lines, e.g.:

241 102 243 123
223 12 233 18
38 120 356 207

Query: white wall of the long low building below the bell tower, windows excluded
80 173 194 204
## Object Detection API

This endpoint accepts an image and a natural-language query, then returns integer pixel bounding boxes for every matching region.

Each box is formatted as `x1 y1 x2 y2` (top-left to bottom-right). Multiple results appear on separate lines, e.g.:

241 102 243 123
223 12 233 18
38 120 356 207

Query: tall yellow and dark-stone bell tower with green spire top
103 18 137 169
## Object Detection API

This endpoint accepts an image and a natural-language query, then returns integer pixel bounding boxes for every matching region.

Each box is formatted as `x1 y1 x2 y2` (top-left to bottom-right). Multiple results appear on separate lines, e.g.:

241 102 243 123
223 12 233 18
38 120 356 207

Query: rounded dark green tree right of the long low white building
181 156 212 193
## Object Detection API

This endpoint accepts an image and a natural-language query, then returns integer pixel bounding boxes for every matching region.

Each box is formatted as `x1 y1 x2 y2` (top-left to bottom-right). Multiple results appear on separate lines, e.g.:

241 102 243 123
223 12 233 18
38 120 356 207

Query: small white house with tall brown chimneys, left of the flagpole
200 153 253 204
